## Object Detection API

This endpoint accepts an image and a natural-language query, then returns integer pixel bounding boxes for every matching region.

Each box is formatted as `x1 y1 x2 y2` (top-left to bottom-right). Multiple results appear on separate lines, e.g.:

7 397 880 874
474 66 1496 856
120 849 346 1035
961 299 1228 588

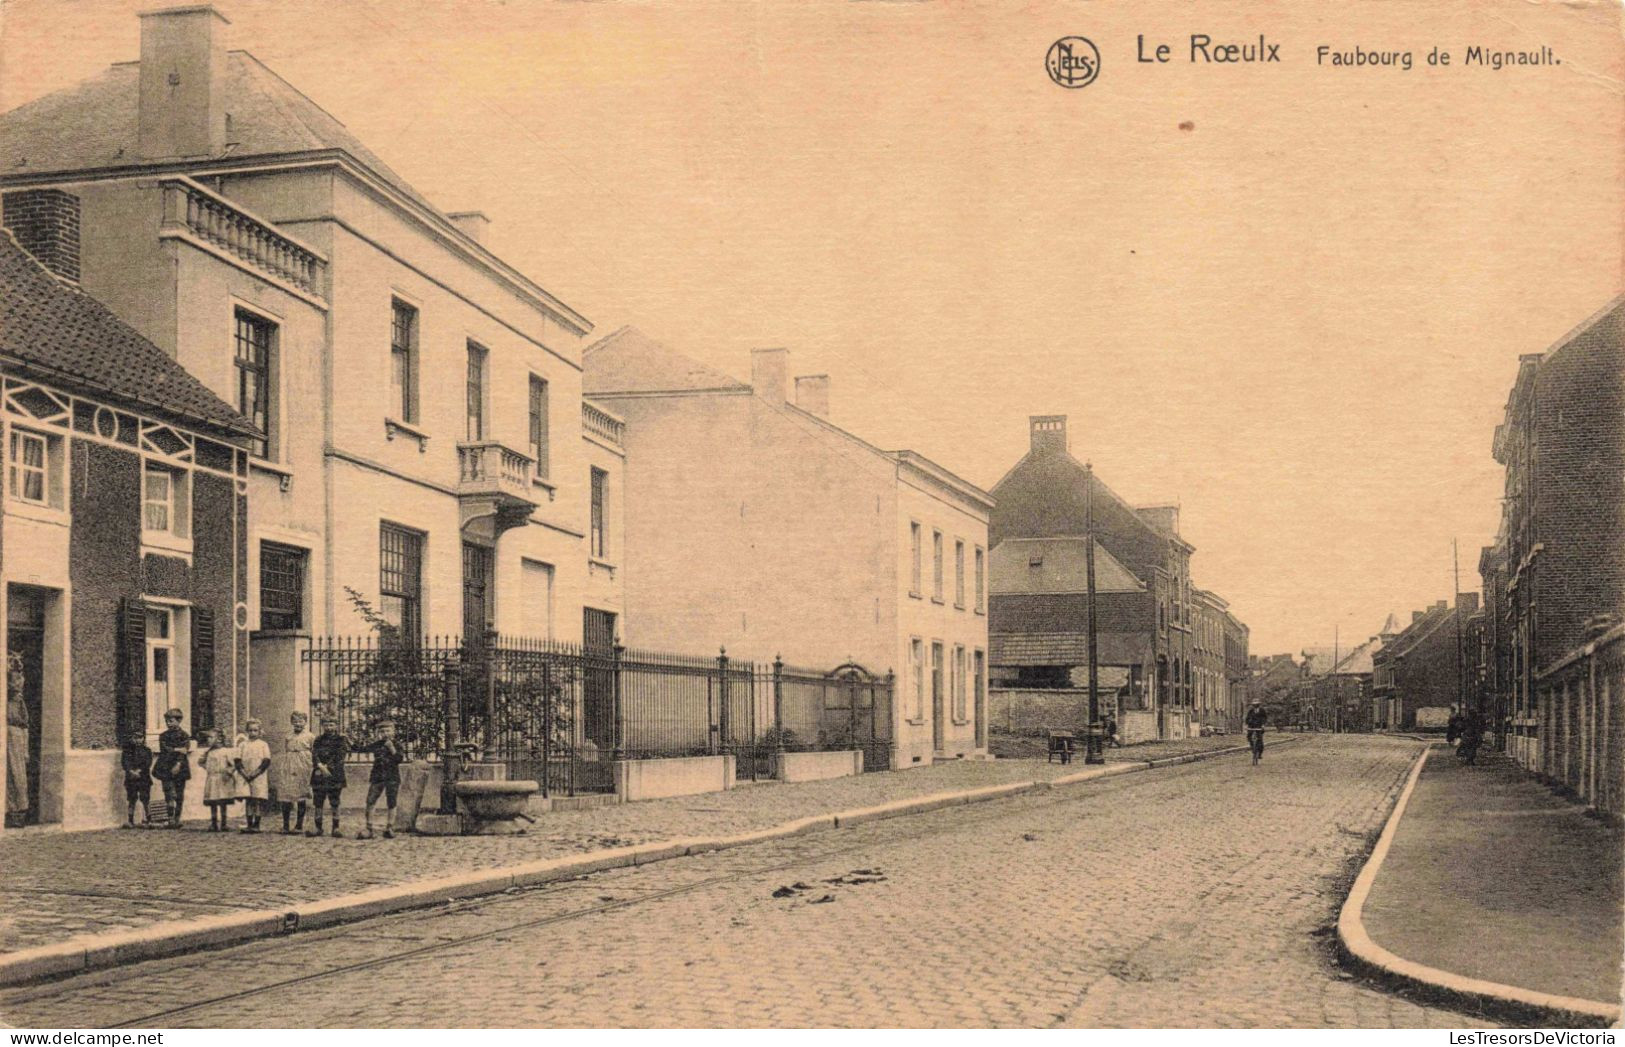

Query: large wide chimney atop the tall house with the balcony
137 5 231 159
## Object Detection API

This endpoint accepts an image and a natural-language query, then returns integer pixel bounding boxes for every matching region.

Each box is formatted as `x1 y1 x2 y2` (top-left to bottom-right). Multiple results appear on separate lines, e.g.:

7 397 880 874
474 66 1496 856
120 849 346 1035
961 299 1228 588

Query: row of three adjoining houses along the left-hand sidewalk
0 7 993 828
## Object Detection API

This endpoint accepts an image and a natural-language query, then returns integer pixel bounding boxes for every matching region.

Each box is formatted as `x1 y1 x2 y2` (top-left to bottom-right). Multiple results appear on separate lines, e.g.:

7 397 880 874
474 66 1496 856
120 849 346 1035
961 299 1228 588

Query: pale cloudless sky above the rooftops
0 0 1625 654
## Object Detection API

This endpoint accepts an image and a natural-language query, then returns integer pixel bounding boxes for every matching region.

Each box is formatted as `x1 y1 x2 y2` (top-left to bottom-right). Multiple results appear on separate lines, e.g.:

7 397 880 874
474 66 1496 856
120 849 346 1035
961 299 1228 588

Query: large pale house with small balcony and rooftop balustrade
0 5 626 744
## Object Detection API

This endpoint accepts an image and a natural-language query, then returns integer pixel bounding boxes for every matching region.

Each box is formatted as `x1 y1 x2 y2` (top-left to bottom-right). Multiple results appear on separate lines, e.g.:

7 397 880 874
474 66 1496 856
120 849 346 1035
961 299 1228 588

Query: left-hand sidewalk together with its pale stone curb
0 740 1267 985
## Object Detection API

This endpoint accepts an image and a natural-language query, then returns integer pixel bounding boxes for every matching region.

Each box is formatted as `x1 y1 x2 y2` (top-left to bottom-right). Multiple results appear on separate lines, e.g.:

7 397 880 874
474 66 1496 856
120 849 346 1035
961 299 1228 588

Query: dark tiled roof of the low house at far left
0 231 258 436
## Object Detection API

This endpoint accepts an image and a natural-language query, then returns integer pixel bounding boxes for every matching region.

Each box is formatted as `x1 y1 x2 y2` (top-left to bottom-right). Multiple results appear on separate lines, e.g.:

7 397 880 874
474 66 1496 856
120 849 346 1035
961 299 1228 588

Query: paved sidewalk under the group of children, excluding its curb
0 738 1235 964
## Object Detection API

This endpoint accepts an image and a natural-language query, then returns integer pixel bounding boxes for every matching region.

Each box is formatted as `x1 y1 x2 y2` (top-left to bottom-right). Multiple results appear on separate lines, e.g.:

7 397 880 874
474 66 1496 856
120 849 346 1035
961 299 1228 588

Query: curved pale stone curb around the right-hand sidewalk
1337 743 1620 1027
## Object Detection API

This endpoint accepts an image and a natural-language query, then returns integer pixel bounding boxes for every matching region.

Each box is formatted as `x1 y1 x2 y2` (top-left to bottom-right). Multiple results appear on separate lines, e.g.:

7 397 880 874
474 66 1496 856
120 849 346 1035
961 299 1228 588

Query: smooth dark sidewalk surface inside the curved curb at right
1363 748 1625 1005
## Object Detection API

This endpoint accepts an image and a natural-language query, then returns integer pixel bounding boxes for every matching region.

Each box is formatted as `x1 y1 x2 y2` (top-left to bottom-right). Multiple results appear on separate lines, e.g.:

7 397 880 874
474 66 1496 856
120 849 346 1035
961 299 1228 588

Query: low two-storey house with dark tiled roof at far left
0 232 262 829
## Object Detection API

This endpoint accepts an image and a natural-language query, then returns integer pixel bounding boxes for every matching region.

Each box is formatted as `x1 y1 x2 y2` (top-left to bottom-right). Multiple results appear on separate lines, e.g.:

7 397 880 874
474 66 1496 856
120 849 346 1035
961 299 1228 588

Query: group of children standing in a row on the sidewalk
120 709 405 839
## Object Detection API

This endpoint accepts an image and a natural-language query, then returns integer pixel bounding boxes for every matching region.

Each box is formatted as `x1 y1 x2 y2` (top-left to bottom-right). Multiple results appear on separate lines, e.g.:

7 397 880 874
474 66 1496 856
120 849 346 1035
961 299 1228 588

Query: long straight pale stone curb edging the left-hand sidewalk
0 734 1267 987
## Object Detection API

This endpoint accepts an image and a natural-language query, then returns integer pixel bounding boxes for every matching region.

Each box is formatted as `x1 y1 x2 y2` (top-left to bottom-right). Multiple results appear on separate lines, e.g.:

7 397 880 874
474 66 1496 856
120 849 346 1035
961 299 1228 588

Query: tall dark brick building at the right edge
1480 299 1625 813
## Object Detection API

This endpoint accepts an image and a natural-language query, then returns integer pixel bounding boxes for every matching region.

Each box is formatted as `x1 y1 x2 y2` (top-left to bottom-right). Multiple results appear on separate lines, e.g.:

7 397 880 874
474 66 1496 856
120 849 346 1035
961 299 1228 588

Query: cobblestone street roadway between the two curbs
0 736 1495 1027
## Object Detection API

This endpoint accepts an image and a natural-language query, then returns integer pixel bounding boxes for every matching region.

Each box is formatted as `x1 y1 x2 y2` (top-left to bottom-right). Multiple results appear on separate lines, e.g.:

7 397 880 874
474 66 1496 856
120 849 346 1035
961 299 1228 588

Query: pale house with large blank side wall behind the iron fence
585 328 993 767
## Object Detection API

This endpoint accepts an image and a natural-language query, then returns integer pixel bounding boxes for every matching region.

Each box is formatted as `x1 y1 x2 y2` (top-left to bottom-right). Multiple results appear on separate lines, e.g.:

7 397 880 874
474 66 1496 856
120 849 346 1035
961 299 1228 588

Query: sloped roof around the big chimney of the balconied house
0 50 436 210
